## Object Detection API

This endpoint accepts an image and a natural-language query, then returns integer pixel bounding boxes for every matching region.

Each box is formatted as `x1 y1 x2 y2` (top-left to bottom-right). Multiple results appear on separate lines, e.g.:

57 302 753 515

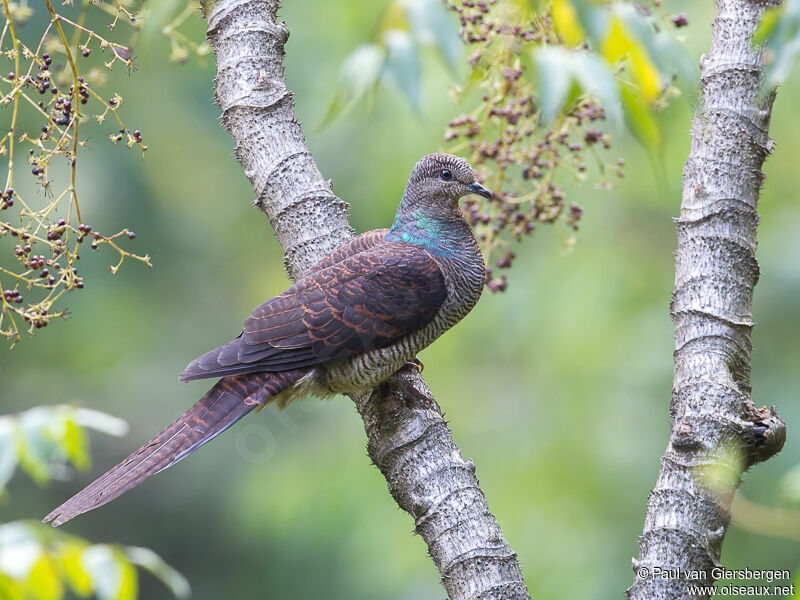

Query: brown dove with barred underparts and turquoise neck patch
43 153 492 527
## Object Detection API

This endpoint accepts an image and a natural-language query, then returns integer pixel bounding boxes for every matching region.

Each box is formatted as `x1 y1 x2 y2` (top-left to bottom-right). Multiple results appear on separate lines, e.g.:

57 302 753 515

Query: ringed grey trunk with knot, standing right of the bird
628 0 786 600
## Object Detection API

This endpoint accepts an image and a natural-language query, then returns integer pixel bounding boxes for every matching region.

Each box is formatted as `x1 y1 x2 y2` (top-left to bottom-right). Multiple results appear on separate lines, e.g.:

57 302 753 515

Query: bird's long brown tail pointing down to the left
43 371 301 527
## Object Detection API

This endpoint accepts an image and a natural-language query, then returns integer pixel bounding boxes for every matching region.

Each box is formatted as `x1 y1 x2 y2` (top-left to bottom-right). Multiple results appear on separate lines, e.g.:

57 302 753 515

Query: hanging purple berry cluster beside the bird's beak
444 0 623 292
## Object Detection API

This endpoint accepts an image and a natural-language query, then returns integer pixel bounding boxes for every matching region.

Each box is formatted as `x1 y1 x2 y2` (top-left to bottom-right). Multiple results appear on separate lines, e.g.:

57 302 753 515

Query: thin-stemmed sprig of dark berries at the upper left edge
0 0 156 343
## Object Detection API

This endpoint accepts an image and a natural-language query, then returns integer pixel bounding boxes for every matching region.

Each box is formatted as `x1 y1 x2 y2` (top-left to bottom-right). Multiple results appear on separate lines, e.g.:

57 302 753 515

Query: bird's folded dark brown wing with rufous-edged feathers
180 242 447 381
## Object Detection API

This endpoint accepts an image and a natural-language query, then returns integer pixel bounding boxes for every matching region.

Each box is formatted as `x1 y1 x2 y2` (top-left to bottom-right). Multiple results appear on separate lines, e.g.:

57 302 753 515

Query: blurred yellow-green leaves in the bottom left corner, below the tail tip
0 521 189 600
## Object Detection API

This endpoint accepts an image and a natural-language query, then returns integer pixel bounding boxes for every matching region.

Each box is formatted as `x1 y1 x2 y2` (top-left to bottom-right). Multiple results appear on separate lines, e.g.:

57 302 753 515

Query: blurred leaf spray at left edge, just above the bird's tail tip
0 405 128 495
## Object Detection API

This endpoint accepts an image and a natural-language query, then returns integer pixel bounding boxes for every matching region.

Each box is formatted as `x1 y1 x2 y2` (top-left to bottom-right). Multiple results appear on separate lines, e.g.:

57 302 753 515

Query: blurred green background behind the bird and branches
0 0 800 600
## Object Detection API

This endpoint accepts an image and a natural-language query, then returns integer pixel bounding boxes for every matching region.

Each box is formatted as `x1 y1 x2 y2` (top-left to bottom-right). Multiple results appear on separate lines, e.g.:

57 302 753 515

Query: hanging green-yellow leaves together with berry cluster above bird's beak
326 0 696 291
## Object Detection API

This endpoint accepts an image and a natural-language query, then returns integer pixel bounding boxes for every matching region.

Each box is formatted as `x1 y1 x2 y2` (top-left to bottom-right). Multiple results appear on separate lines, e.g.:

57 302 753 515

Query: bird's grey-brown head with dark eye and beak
406 153 492 206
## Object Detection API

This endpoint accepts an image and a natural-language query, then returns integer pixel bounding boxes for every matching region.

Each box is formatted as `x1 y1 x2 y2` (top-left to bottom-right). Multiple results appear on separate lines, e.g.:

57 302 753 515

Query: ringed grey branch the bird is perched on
203 0 530 600
